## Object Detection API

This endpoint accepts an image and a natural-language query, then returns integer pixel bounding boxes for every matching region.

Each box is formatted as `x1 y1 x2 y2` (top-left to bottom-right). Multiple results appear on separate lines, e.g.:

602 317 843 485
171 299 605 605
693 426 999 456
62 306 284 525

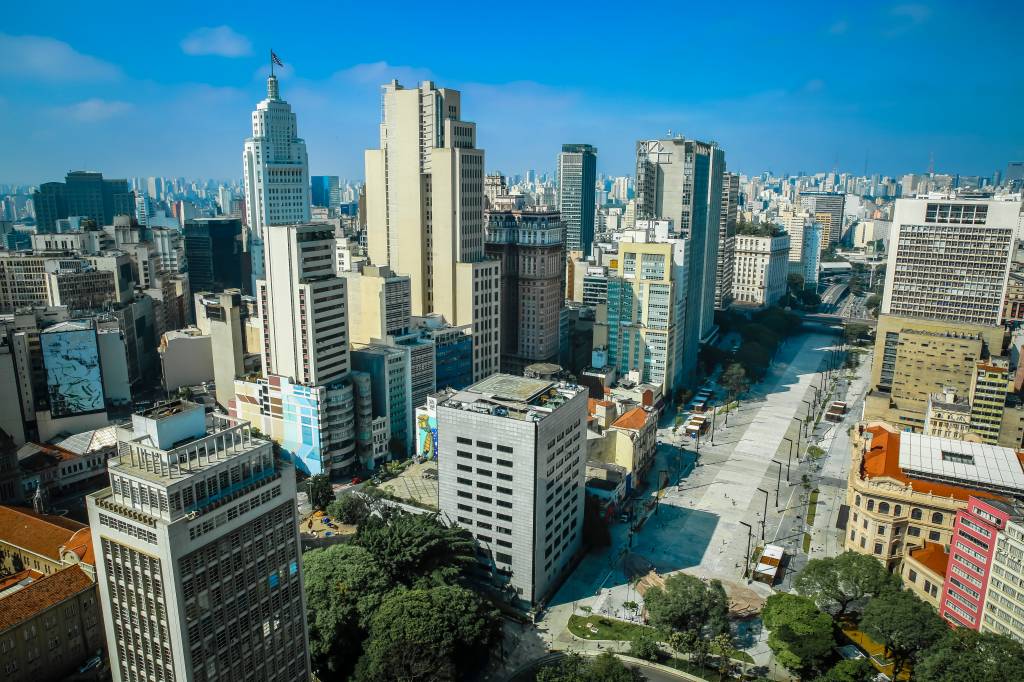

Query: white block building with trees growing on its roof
732 230 790 307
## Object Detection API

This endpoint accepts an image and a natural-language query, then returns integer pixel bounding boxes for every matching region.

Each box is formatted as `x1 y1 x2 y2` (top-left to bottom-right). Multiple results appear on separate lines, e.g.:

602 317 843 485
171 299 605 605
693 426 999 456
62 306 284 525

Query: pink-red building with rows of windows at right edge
939 497 1017 630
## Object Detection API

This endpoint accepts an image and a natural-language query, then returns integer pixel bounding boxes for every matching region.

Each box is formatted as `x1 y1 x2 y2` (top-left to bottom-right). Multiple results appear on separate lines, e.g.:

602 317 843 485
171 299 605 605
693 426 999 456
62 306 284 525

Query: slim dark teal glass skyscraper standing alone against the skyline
556 144 597 256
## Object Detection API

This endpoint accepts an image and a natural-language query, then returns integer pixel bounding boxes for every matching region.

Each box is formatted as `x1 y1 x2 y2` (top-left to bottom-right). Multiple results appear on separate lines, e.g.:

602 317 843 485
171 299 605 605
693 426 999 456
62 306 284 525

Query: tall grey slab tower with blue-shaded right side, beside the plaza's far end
636 136 725 360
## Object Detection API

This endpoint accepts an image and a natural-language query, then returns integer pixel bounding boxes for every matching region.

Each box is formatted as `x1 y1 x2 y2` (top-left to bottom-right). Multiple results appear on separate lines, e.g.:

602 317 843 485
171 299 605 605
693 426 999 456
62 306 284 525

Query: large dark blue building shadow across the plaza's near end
549 504 721 606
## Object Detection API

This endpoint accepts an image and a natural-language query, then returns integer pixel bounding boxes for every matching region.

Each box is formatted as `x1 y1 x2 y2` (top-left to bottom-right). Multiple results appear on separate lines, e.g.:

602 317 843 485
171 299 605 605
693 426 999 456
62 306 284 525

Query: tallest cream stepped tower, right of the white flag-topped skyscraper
366 81 501 379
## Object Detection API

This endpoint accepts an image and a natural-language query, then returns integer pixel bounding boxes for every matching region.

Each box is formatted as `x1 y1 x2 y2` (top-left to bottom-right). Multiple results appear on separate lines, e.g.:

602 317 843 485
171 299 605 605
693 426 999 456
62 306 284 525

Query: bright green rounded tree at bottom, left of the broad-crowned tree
761 592 836 676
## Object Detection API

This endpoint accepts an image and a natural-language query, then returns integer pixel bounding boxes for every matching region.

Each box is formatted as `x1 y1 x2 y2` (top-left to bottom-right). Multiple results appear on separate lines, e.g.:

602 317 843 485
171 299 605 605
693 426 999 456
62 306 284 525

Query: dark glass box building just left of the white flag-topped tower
182 217 242 292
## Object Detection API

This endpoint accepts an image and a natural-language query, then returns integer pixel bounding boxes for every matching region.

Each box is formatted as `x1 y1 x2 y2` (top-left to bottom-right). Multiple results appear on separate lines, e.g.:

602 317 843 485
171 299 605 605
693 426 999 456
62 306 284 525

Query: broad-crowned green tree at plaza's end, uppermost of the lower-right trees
793 551 899 617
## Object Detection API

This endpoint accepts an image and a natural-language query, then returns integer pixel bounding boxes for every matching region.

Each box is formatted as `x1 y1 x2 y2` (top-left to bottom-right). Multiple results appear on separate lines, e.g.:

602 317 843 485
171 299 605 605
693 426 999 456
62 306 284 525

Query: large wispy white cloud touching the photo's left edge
0 33 121 81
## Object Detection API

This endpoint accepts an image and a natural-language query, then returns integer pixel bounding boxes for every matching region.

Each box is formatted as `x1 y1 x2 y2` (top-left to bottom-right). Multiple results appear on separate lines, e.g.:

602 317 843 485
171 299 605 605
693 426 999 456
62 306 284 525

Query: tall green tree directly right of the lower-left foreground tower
302 545 391 679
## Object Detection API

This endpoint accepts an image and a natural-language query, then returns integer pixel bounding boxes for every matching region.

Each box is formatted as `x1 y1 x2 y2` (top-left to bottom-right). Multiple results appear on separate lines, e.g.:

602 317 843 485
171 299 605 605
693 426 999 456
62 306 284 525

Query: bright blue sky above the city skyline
0 0 1024 182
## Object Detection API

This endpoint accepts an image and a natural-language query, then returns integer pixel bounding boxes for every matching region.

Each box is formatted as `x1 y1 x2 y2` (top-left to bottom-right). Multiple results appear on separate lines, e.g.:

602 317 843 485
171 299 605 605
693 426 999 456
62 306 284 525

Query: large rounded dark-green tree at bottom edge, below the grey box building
355 585 501 682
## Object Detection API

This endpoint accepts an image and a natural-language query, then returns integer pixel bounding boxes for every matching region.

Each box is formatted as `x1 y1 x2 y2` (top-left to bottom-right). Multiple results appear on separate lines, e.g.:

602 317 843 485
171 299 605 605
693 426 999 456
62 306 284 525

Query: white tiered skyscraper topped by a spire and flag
242 74 309 282
